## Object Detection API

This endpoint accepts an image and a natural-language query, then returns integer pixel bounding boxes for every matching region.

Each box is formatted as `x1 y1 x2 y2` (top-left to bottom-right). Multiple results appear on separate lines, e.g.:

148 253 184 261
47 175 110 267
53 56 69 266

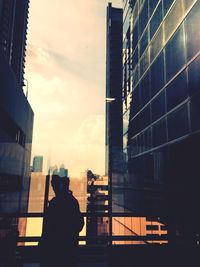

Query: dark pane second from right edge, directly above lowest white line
167 104 189 140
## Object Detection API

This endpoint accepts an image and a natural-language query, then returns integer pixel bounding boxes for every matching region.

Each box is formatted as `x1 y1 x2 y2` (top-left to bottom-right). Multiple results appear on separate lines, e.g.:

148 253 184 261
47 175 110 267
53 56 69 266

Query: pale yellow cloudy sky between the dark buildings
25 0 122 176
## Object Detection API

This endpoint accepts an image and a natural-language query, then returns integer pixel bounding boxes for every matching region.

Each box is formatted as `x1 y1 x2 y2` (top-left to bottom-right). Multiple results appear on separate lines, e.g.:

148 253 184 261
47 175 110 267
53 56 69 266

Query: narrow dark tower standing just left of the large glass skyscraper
105 3 123 214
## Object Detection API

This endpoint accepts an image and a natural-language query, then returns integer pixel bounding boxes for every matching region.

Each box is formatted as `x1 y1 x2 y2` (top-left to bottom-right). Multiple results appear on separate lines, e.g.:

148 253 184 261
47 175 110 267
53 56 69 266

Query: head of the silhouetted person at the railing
51 175 69 196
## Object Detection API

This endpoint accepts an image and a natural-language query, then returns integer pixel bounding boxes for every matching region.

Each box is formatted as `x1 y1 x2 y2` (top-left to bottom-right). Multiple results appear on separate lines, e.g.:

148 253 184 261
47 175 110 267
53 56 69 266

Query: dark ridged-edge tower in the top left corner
0 0 29 86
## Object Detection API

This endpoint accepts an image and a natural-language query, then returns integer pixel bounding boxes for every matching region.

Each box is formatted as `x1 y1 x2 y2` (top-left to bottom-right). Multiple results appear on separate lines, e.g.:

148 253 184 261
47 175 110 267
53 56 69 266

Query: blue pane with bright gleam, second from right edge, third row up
165 25 186 81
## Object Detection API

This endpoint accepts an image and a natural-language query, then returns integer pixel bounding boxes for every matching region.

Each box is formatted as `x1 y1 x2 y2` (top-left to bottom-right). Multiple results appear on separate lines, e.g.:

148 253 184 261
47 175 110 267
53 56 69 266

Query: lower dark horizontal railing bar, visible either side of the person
18 235 168 242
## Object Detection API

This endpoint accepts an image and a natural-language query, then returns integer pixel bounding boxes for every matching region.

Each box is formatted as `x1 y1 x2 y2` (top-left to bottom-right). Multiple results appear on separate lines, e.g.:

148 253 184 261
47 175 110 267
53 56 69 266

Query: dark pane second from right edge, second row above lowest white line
166 71 188 111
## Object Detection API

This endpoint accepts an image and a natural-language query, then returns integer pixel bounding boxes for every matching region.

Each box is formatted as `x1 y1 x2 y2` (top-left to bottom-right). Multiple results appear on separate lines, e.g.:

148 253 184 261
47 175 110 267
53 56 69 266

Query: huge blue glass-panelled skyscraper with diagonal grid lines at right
123 0 200 239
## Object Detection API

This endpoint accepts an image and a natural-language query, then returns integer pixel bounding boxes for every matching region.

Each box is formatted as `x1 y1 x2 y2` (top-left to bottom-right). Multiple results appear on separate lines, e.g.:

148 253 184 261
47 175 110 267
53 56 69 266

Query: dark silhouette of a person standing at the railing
39 175 84 267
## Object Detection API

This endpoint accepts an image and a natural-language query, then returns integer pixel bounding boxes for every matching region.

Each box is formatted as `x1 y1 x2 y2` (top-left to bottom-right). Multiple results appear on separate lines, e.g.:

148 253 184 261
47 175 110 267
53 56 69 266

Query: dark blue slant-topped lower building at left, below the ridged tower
0 51 33 213
